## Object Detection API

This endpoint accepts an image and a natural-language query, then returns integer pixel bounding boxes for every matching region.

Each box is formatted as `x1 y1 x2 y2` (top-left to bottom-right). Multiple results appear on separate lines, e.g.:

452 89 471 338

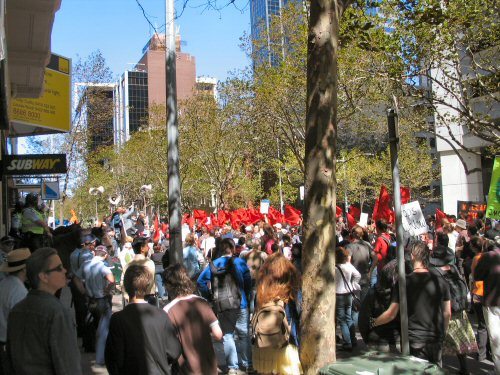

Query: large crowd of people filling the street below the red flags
0 198 500 374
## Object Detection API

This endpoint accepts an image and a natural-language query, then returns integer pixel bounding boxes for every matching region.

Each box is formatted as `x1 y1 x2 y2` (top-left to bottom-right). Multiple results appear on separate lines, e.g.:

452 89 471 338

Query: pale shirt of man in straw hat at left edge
0 275 28 342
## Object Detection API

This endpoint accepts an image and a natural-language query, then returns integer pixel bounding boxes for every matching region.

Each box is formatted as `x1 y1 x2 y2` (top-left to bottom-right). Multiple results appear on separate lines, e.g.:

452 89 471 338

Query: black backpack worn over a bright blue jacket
209 257 241 314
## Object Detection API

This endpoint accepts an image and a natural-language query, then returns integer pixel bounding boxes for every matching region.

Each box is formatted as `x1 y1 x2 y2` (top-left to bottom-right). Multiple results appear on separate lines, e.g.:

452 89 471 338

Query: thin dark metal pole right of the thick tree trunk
387 109 410 355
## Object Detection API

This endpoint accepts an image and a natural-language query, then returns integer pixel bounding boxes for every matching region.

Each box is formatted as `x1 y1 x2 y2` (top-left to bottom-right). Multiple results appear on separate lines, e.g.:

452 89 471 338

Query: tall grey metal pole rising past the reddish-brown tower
165 0 182 264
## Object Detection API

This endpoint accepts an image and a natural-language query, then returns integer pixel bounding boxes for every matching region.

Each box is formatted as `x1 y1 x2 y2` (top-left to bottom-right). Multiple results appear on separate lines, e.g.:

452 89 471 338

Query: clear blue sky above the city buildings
52 0 250 80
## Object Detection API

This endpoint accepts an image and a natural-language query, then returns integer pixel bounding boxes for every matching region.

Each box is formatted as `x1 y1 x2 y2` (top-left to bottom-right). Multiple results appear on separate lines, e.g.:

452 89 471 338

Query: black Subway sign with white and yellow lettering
2 154 67 176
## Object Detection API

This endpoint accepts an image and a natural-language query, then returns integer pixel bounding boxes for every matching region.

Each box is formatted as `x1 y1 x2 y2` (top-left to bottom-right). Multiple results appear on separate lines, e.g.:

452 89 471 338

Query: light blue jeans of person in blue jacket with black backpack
223 308 252 369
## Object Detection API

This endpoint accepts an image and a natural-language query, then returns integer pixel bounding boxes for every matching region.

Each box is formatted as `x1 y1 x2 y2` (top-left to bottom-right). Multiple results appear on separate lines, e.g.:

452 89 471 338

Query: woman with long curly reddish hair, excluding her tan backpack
252 252 302 375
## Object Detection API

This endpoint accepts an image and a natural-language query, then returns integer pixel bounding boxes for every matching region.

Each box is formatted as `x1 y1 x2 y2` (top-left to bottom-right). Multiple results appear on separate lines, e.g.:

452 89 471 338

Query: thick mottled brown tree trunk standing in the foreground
301 0 351 374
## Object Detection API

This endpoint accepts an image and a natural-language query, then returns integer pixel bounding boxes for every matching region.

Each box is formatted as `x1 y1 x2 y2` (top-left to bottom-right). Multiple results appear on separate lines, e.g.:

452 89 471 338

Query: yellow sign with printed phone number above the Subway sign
10 54 71 132
